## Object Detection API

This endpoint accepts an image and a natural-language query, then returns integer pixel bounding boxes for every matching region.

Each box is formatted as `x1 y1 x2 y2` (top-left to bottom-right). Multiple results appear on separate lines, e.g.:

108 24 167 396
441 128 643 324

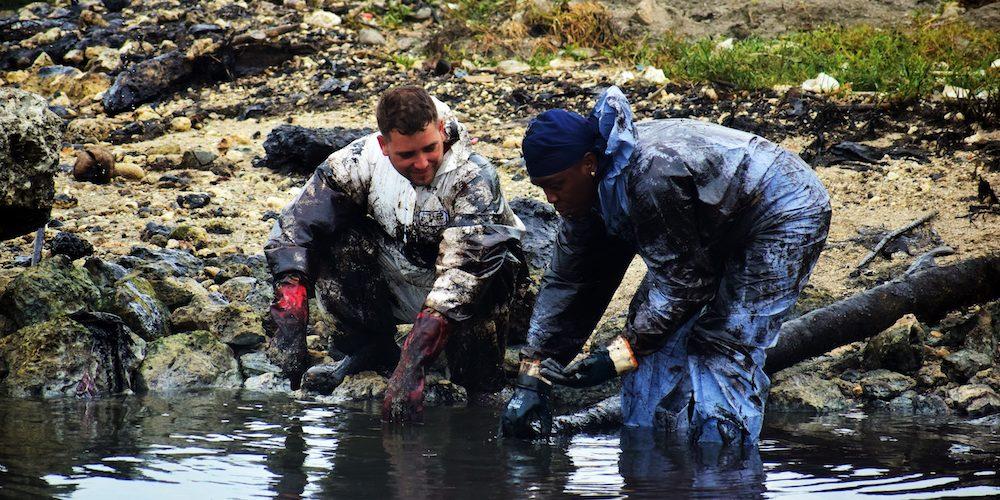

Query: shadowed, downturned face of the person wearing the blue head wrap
531 153 597 218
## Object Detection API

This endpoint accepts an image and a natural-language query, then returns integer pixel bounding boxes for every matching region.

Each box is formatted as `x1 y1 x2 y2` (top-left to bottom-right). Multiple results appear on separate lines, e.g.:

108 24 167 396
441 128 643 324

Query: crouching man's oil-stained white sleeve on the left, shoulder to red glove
264 138 371 277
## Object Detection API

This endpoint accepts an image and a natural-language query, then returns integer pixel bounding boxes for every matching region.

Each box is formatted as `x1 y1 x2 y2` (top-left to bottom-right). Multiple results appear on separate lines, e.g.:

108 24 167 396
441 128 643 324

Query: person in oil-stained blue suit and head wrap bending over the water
501 87 830 443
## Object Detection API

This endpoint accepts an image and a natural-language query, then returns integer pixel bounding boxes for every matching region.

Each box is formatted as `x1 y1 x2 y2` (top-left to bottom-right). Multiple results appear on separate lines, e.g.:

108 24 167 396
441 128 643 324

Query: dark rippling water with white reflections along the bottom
0 393 1000 498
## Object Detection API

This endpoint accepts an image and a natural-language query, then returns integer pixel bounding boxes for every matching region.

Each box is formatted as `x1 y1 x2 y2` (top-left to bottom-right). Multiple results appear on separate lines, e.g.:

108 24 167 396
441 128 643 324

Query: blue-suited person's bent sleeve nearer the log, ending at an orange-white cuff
626 156 719 356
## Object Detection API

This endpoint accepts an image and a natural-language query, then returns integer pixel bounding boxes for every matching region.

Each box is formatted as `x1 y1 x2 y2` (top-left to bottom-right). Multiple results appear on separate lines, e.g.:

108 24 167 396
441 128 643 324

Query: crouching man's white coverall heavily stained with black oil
265 99 524 392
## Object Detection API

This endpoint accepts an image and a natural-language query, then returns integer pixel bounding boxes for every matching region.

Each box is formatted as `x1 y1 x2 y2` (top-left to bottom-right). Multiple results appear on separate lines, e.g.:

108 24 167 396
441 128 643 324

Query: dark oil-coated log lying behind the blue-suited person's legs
552 255 1000 434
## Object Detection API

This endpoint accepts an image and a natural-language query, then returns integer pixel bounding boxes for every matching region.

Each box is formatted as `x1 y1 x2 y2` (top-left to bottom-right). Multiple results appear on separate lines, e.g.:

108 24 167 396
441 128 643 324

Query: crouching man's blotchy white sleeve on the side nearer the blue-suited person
424 162 524 321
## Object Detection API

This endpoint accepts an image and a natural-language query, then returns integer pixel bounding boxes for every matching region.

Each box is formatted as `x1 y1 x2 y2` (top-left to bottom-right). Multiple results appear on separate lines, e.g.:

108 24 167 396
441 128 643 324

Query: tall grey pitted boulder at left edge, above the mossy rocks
0 87 62 240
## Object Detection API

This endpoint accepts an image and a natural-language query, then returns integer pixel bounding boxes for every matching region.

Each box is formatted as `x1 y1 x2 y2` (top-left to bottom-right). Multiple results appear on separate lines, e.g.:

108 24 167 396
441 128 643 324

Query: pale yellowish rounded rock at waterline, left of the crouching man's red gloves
139 331 242 392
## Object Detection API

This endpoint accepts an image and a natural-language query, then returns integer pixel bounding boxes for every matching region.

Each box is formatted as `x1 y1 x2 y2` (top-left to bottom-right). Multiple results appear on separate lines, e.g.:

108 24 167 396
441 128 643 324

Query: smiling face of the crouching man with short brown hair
378 120 445 186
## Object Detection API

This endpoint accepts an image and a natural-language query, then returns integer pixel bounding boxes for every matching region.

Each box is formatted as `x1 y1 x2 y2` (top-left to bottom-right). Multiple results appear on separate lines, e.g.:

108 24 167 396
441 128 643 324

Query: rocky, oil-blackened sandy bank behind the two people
0 2 1000 424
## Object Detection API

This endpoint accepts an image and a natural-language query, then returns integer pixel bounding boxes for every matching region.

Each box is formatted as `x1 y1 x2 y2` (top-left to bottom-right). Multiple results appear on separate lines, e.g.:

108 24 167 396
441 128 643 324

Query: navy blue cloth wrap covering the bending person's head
521 109 597 177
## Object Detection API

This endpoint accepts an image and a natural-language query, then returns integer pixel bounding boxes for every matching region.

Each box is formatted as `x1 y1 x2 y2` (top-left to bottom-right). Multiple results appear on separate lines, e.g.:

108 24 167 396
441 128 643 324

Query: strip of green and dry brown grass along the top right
440 0 1000 100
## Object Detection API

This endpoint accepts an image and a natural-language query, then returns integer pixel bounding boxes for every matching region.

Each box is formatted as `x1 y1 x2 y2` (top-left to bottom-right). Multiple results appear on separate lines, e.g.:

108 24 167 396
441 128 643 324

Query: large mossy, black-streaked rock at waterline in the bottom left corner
0 313 146 397
